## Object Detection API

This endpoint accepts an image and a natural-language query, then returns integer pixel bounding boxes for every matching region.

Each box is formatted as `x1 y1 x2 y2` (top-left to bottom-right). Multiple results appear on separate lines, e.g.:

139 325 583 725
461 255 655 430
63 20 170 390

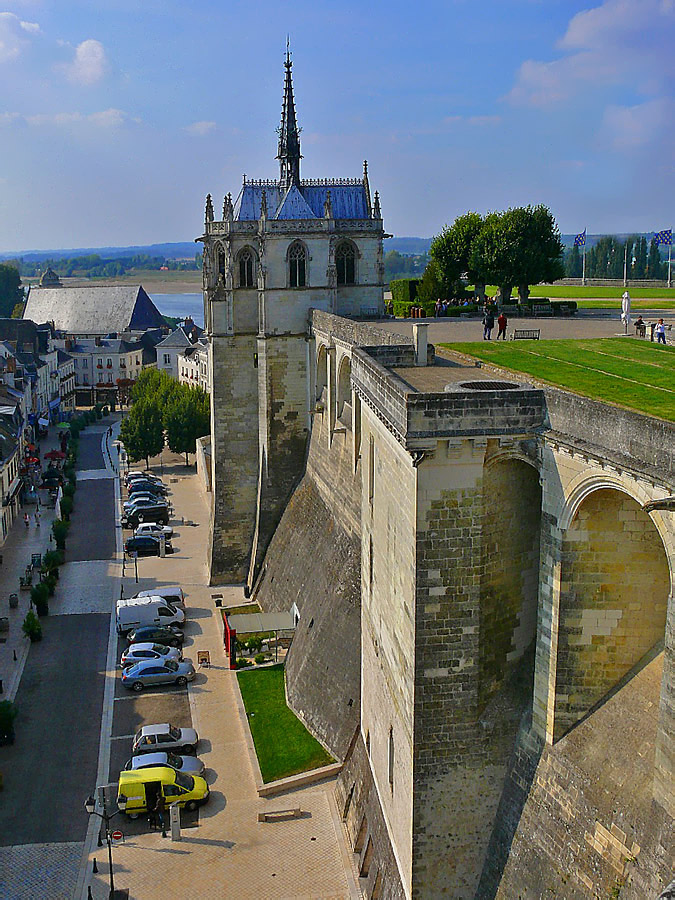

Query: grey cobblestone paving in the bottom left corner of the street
0 843 84 900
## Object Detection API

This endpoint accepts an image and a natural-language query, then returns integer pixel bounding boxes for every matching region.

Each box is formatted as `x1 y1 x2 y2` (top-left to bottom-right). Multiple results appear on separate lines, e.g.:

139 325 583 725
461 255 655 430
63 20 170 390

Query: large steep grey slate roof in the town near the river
23 285 164 334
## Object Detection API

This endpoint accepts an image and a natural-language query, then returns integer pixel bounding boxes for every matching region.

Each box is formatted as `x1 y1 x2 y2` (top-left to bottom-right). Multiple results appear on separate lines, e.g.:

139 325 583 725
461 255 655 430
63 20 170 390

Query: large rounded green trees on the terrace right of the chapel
417 205 565 303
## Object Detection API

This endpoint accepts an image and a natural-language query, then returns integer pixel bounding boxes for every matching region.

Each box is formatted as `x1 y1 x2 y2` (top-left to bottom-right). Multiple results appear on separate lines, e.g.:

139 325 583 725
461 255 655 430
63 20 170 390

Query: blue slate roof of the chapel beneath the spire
234 181 370 222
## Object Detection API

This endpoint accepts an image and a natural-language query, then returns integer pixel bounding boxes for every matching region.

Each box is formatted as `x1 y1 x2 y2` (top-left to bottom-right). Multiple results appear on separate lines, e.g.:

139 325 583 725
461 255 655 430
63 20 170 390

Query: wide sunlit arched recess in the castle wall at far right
553 488 672 740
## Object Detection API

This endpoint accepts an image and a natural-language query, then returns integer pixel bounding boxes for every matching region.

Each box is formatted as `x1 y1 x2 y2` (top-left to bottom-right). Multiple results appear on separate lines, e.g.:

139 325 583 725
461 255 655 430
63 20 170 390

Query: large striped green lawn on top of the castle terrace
440 338 675 422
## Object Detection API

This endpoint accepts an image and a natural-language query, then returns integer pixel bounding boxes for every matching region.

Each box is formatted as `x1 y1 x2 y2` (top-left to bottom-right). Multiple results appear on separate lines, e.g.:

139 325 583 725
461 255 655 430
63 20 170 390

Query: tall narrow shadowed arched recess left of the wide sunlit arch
479 454 542 704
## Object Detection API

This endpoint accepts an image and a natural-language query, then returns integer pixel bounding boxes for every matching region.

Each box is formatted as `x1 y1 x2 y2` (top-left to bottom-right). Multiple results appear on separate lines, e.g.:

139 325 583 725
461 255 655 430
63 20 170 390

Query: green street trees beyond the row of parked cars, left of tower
120 369 211 467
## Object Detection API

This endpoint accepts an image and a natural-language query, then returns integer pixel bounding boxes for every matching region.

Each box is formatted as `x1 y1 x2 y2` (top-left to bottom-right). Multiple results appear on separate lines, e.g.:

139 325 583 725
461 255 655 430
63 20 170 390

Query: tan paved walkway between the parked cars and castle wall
84 452 361 900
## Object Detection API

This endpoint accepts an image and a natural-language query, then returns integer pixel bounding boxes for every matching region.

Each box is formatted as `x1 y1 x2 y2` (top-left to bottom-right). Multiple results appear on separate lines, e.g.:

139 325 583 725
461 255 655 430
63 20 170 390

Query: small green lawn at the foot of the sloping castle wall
237 666 335 782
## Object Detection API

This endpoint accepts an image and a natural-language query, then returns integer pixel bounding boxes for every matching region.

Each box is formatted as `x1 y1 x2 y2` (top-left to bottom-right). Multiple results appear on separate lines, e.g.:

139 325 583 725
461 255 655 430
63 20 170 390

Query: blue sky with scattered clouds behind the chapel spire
0 0 675 252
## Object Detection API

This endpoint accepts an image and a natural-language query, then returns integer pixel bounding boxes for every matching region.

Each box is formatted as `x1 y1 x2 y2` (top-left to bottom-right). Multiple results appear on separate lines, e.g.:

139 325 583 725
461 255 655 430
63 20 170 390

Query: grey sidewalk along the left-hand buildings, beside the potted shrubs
0 425 69 700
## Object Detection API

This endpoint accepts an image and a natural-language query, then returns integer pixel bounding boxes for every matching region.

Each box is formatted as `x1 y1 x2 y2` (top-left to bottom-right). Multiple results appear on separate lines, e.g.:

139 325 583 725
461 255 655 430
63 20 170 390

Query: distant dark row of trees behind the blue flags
565 235 668 281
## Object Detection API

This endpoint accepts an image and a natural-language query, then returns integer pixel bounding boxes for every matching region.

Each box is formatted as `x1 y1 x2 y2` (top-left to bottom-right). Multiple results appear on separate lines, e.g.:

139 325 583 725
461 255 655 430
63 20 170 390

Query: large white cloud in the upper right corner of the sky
508 0 675 106
